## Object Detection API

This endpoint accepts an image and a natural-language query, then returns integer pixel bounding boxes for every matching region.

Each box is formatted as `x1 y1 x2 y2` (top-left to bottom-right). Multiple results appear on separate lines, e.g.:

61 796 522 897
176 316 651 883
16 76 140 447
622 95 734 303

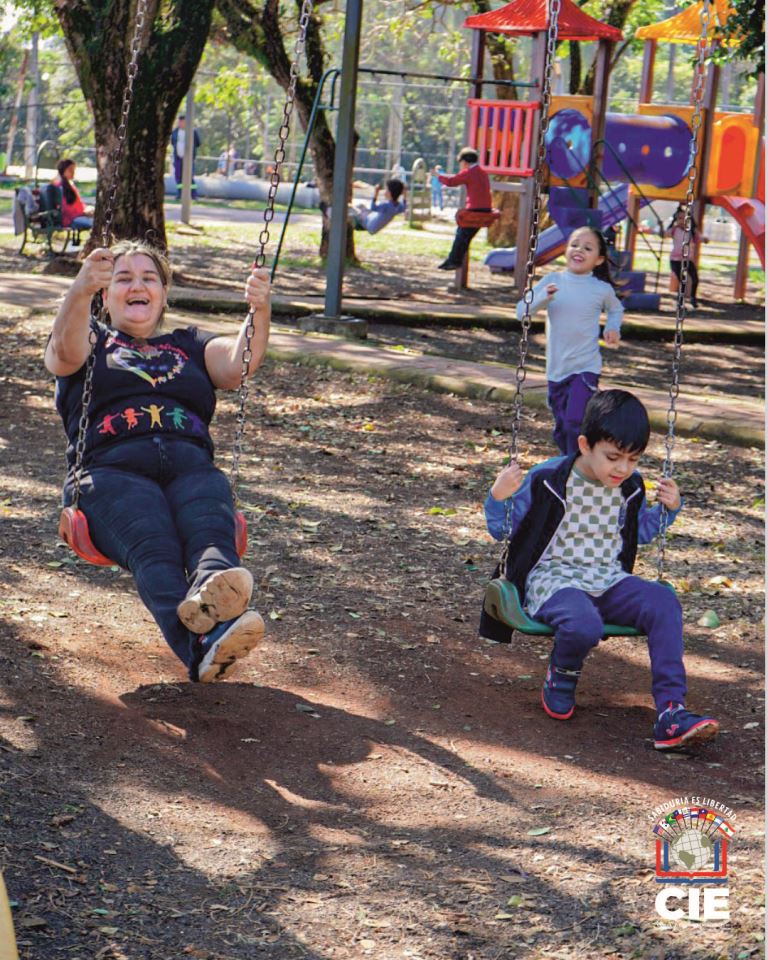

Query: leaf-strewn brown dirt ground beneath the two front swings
0 234 764 960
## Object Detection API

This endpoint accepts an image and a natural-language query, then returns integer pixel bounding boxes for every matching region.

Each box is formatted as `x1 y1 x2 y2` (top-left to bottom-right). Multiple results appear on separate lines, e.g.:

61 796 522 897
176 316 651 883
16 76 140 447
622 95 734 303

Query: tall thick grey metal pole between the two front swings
325 0 363 319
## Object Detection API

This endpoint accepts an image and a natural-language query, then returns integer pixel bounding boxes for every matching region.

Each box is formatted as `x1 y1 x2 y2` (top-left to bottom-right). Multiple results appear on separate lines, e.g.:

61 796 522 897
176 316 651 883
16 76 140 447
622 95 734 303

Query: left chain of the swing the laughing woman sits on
72 0 148 510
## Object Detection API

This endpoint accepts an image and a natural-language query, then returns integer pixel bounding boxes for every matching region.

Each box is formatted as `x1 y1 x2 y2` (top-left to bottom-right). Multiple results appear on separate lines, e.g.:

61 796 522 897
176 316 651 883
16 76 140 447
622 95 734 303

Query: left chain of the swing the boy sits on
500 0 561 556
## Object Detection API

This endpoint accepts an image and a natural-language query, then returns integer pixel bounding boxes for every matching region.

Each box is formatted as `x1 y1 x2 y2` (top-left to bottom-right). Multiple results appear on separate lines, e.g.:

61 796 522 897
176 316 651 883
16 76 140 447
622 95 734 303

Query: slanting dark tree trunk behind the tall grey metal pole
216 0 357 263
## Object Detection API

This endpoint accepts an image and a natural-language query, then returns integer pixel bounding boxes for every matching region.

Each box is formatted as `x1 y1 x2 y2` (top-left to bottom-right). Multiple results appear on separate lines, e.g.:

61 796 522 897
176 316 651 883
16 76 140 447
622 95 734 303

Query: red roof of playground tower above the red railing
464 0 622 40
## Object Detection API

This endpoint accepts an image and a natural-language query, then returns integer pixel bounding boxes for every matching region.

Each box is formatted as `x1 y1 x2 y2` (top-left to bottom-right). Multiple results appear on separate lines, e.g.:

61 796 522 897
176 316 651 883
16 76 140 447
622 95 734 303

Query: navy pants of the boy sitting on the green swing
536 577 687 713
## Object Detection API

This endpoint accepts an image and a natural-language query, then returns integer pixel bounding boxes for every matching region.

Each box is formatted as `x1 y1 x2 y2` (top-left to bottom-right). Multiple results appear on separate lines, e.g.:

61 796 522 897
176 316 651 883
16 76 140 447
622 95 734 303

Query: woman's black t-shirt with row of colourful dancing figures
56 324 216 466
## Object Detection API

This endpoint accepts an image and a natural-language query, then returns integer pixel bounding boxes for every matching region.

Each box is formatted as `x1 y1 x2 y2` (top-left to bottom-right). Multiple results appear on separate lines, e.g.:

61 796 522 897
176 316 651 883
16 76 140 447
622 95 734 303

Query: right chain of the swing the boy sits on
657 0 710 580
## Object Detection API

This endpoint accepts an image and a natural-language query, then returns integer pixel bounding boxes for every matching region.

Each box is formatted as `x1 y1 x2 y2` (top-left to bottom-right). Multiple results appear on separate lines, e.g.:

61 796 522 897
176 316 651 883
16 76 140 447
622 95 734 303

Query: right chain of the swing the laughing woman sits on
230 0 313 505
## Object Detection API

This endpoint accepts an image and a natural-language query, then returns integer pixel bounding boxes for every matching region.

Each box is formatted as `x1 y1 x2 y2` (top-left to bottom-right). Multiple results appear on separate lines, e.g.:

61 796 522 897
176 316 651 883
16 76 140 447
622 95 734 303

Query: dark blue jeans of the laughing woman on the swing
64 436 240 679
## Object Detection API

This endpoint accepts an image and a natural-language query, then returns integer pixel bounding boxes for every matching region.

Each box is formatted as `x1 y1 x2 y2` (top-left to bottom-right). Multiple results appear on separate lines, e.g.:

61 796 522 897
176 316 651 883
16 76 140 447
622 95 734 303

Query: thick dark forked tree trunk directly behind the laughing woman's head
56 0 214 250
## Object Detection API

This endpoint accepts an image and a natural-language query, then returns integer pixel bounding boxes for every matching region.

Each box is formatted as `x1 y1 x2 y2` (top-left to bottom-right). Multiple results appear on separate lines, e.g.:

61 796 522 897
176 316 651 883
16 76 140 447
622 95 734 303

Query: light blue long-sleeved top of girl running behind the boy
517 270 624 381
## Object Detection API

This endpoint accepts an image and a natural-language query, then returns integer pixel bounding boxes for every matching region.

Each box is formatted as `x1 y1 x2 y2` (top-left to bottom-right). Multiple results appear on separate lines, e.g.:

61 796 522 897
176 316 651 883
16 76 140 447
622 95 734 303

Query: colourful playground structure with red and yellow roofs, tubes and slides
465 0 765 309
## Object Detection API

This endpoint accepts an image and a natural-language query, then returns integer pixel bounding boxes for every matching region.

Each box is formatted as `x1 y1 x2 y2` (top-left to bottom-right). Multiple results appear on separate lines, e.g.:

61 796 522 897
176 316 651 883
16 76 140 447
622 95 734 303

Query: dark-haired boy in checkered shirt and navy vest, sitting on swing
481 390 720 750
